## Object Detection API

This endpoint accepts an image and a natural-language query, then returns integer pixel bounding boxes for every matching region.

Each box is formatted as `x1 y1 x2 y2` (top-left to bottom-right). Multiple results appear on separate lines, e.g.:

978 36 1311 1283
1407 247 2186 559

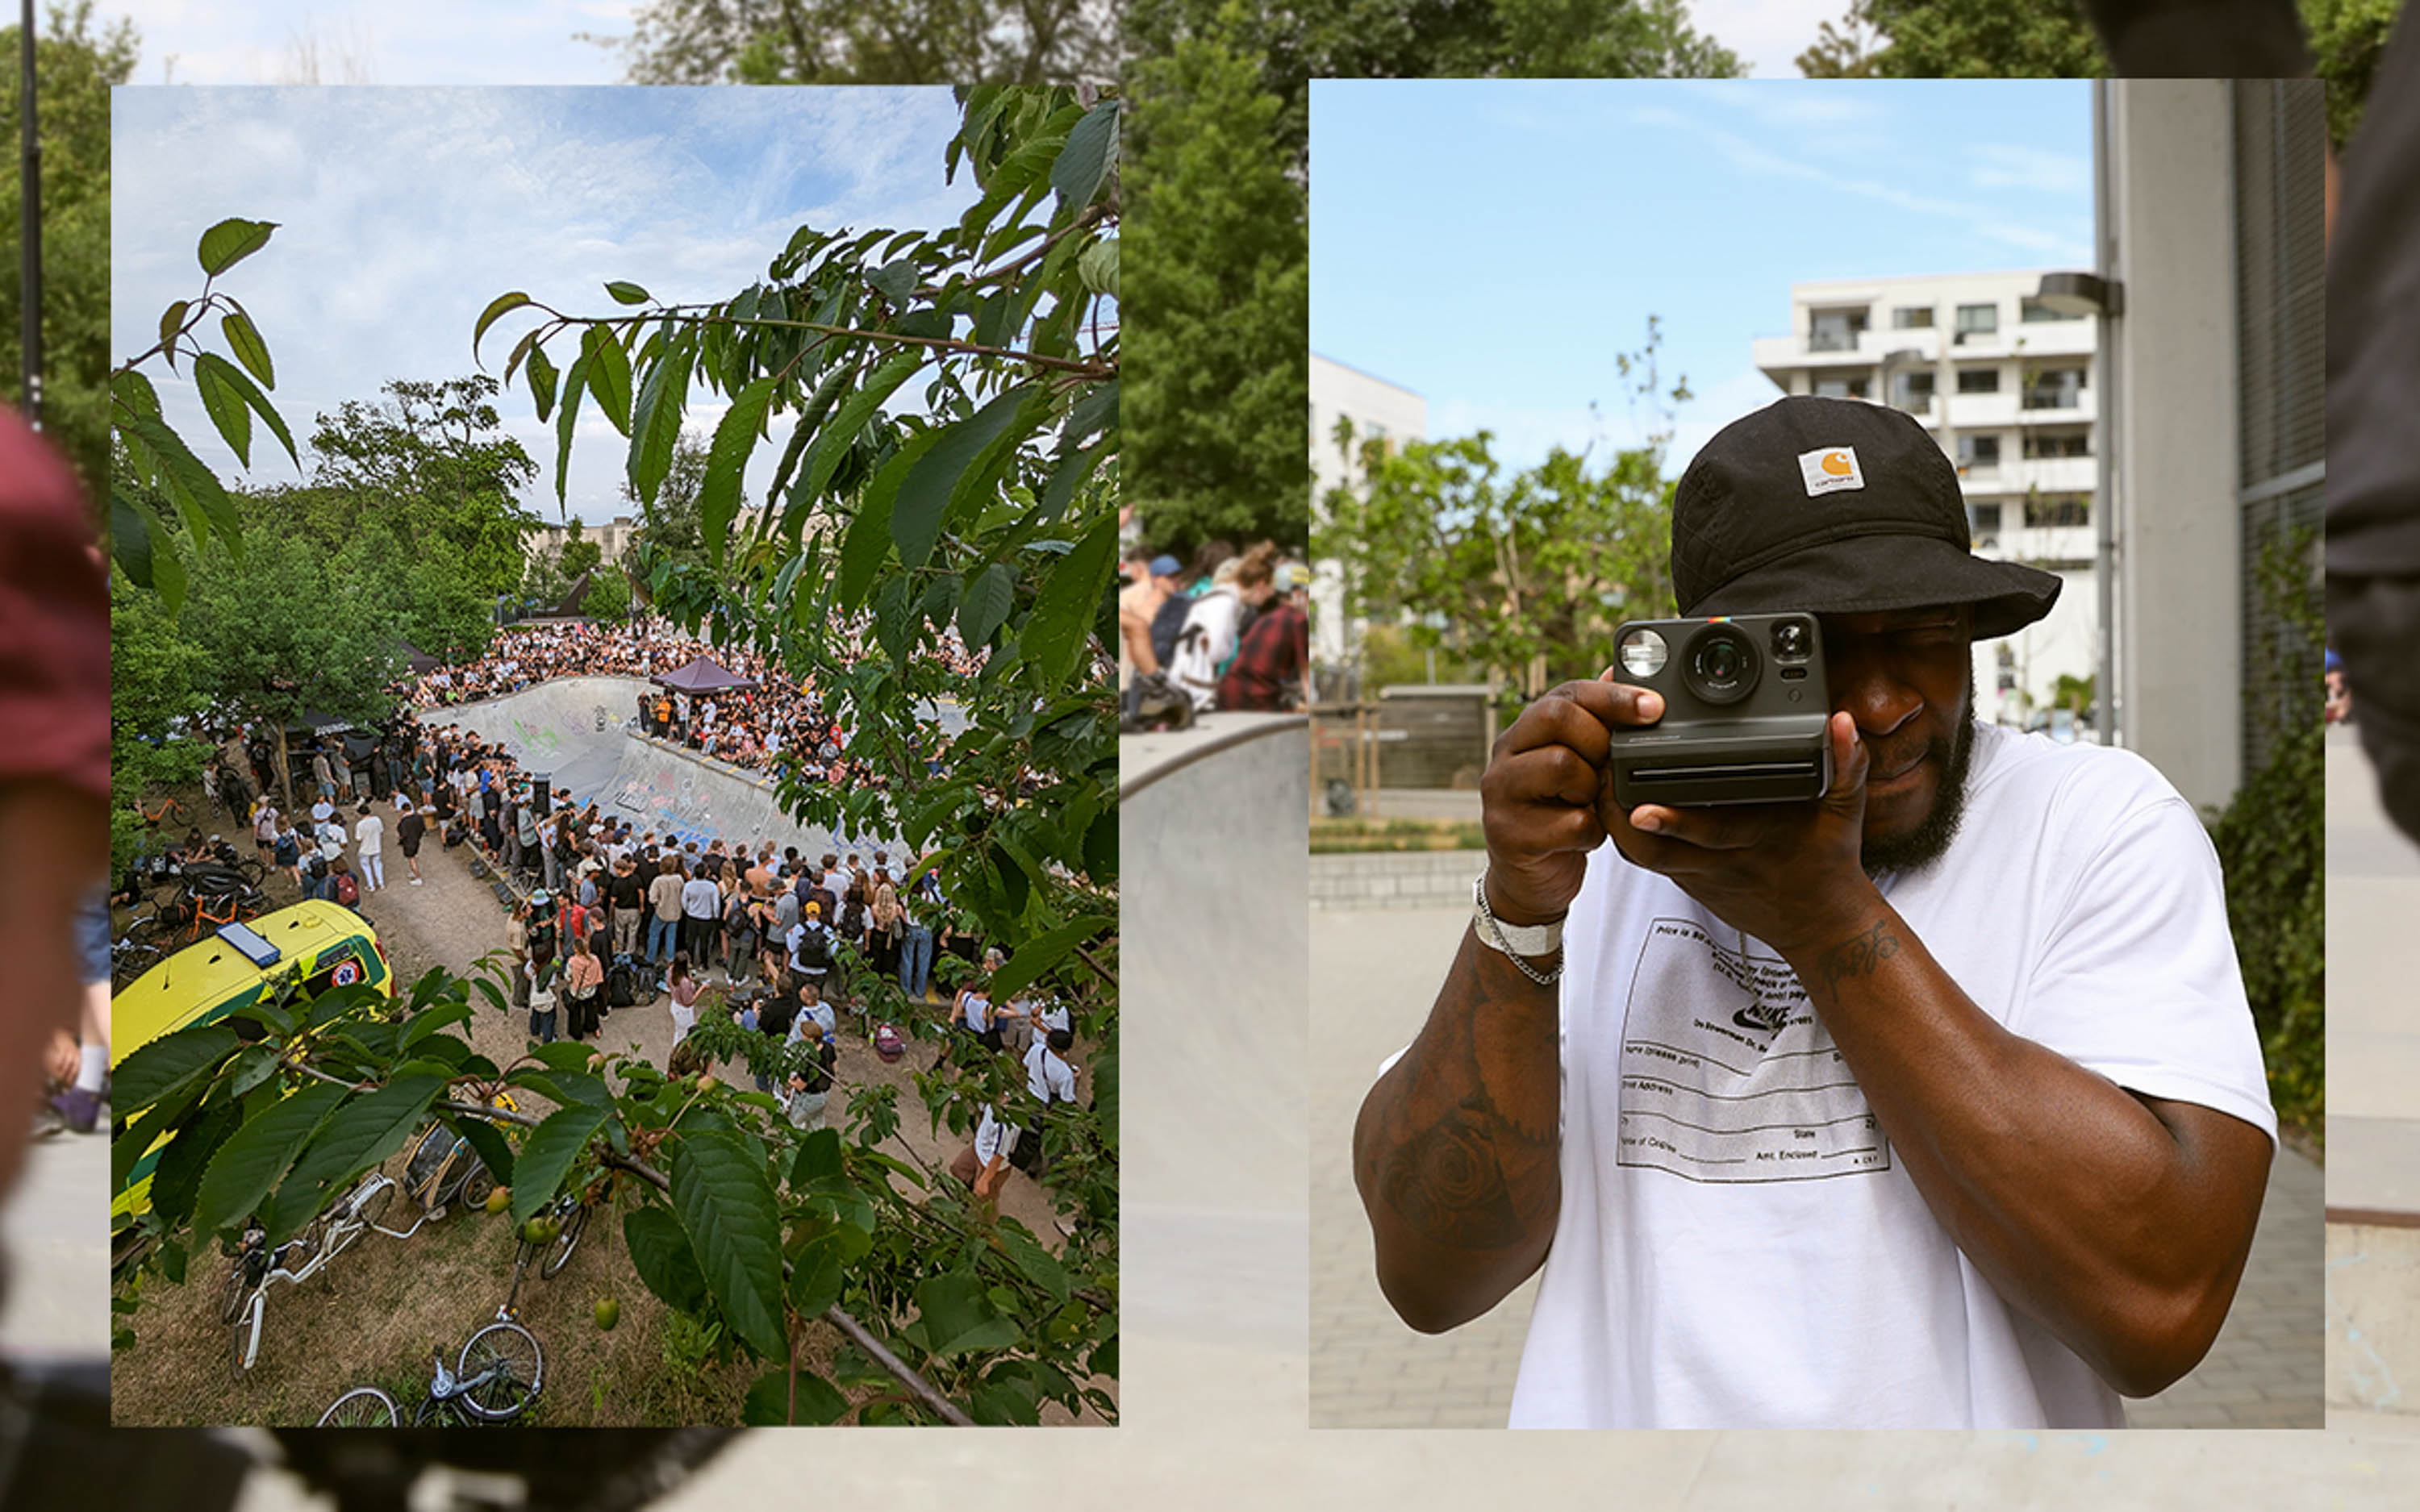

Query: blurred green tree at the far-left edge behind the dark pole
0 0 136 501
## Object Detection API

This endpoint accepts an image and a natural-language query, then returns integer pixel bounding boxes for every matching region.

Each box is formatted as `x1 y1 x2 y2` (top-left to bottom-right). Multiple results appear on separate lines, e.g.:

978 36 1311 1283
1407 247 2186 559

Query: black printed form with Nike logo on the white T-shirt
1617 919 1890 1181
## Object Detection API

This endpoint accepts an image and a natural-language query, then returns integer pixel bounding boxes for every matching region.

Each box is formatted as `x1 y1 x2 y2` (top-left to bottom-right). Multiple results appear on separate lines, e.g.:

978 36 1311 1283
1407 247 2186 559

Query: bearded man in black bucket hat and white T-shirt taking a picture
1353 397 2275 1427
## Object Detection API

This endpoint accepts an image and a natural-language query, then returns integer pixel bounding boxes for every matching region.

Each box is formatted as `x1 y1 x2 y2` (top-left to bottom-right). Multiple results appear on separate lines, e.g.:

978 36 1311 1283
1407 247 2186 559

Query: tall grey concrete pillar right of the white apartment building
2101 80 2243 806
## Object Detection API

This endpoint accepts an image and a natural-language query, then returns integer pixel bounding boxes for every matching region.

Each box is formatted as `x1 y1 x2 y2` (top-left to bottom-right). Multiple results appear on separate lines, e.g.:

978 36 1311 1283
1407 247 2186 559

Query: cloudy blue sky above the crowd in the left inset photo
111 87 975 520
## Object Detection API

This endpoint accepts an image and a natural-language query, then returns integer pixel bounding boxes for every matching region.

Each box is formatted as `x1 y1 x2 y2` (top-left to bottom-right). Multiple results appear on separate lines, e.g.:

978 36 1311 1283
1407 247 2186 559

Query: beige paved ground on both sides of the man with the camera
1312 856 2326 1427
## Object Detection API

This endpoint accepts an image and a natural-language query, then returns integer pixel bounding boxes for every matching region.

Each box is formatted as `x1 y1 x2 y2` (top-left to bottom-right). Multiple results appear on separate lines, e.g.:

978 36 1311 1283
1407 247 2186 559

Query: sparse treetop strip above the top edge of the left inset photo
615 0 1116 85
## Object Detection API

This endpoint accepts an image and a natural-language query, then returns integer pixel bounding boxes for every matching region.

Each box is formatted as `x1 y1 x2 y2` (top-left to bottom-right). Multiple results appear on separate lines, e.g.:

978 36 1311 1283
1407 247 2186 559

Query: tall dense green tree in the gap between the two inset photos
1125 15 1312 556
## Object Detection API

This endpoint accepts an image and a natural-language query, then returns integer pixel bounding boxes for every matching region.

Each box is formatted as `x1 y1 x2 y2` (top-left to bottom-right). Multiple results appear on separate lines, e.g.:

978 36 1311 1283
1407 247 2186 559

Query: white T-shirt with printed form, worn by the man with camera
1512 728 2277 1430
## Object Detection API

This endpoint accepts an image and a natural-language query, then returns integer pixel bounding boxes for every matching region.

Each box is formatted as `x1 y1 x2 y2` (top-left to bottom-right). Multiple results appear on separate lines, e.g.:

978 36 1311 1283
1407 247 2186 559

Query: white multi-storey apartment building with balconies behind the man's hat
1762 271 2101 726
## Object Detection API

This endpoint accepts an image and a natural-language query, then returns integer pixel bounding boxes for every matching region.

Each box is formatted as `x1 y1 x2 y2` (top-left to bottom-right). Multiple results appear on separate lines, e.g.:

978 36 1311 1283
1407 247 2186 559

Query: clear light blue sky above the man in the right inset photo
1312 80 2093 474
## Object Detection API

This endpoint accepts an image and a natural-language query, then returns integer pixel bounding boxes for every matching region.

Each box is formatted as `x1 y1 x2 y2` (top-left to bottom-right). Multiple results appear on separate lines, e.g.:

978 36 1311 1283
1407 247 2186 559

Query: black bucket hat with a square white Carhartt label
1672 394 2062 641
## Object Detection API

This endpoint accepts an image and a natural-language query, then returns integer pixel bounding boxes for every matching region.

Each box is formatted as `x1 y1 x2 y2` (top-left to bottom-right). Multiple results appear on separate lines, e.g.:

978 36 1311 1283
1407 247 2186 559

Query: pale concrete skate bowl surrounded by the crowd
419 677 886 856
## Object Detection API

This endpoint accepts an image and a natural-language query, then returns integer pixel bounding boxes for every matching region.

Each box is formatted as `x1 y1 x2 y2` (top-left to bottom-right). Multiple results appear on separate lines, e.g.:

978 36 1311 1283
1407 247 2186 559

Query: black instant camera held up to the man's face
1612 614 1832 808
